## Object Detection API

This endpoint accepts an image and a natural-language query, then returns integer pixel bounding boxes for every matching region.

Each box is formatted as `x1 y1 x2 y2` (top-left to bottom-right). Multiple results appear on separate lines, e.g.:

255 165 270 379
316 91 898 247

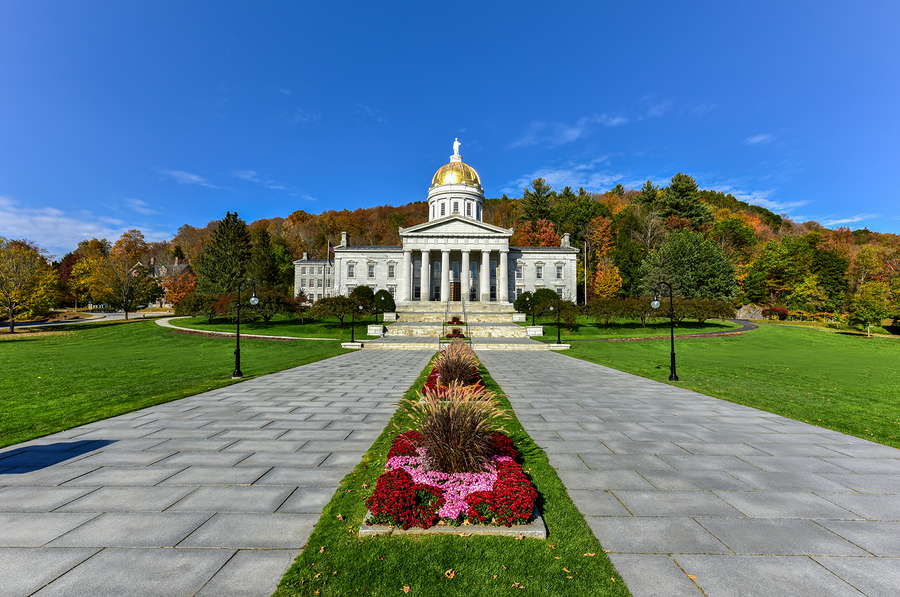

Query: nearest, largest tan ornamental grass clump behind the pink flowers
410 382 509 473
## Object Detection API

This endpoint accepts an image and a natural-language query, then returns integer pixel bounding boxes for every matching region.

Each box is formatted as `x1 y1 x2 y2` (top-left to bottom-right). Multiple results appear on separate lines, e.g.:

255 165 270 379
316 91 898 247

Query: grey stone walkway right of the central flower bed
478 351 900 597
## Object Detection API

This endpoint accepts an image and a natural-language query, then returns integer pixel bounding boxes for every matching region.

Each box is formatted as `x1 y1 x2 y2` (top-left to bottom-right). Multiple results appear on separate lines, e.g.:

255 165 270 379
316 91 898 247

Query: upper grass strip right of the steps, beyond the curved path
520 316 741 342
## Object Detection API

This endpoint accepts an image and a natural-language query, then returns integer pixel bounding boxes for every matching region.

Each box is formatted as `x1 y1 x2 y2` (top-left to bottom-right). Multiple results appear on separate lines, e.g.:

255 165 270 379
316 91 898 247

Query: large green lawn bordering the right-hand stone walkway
567 326 900 448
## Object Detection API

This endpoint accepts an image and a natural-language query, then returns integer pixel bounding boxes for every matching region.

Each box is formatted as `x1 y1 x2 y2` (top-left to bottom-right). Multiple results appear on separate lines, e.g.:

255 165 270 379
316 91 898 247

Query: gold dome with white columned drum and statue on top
428 139 484 221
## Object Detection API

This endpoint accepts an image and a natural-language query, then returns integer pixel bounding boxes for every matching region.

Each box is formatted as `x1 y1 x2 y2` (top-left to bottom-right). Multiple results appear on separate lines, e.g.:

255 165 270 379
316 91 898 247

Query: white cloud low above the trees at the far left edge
0 196 172 258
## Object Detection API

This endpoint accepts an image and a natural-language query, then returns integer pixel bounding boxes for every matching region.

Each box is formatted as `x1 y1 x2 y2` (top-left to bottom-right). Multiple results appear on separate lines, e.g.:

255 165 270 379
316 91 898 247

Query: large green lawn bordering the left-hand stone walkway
0 320 347 446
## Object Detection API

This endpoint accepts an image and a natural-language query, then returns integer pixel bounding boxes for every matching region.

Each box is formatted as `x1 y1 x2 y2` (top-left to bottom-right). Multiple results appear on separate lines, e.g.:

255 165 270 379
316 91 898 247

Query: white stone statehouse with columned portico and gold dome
294 141 578 303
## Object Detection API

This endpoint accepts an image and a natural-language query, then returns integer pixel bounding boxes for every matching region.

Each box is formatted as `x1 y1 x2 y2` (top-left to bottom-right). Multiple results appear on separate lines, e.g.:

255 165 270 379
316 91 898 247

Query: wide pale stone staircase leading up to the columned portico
363 301 564 350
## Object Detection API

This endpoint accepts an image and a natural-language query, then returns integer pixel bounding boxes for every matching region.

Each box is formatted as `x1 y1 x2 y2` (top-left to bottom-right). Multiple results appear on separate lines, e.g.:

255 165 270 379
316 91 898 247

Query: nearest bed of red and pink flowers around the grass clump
366 431 537 529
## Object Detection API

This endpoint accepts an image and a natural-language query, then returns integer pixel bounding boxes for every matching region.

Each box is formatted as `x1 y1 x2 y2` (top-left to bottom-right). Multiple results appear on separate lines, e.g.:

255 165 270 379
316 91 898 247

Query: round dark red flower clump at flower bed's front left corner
366 469 444 529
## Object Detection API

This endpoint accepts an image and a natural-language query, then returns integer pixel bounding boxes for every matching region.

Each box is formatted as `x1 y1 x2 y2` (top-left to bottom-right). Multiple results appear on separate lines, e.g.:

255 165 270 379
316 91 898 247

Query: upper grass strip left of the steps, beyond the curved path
172 315 380 342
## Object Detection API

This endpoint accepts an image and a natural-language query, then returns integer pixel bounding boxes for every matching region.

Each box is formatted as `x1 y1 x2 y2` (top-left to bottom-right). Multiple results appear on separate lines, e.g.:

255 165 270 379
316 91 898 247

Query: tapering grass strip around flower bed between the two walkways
275 356 630 597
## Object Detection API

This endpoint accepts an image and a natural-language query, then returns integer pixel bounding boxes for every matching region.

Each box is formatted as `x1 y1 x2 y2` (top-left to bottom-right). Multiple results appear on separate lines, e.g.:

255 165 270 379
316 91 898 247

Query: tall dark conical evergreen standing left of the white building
197 211 252 294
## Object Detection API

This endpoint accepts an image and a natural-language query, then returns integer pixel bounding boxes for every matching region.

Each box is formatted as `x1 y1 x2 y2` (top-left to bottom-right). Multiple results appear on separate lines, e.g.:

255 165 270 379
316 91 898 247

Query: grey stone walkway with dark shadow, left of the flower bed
0 351 433 597
